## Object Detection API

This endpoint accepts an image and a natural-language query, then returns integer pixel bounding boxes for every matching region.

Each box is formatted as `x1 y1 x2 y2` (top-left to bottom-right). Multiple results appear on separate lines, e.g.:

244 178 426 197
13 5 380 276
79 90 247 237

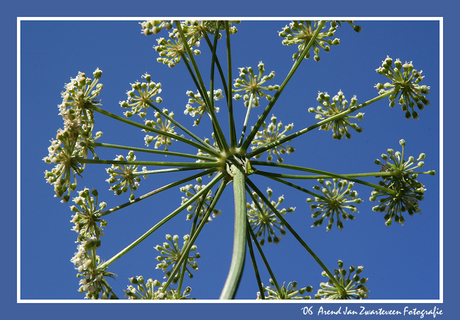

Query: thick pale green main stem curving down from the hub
220 165 247 299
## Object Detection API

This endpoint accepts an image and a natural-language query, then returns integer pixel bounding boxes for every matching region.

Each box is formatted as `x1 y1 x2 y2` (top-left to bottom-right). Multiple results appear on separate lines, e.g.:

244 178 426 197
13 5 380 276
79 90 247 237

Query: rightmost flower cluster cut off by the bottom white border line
315 260 369 300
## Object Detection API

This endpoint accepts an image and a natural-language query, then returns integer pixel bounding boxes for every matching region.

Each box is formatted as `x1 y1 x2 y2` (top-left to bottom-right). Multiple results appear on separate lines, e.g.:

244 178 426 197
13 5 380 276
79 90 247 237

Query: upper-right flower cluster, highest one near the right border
375 56 430 119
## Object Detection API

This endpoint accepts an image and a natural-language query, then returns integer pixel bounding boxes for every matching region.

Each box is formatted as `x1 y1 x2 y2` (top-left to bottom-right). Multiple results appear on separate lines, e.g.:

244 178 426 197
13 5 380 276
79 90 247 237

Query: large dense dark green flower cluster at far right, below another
369 139 435 226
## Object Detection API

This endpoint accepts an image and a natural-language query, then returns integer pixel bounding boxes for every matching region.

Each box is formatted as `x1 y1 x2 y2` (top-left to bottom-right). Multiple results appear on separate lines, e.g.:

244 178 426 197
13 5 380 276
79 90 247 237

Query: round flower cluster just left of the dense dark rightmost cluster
307 178 362 231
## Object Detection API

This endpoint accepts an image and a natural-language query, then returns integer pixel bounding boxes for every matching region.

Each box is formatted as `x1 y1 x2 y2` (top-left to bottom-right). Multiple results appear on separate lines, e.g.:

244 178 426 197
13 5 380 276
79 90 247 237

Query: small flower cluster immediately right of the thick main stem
246 188 295 246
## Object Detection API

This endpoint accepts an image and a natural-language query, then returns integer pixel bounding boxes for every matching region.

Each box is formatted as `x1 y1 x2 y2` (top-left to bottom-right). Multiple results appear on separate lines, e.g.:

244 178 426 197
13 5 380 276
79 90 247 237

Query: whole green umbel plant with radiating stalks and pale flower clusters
44 20 434 299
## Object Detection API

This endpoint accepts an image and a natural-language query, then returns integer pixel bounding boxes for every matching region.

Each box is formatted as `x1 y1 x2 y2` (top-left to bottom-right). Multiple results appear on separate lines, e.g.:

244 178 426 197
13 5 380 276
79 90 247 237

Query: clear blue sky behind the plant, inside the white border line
21 21 440 299
